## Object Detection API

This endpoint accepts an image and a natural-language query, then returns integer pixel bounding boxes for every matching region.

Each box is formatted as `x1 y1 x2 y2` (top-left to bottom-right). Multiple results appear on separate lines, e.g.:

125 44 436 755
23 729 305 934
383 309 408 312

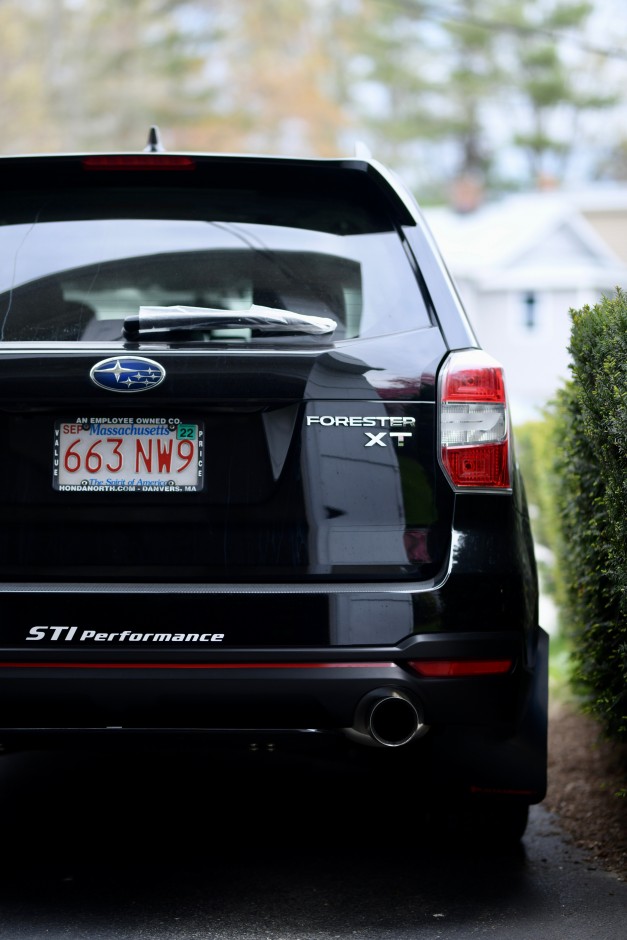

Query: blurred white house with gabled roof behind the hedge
424 186 627 422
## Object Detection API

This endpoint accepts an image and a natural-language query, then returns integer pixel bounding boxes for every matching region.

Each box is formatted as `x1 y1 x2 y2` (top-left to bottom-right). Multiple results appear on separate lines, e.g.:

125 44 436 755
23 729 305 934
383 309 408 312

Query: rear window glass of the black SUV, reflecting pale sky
0 170 429 343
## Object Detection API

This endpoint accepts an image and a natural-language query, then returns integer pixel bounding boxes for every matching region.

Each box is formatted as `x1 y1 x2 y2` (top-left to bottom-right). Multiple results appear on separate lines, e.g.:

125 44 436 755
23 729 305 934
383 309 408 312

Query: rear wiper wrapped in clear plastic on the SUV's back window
123 304 337 339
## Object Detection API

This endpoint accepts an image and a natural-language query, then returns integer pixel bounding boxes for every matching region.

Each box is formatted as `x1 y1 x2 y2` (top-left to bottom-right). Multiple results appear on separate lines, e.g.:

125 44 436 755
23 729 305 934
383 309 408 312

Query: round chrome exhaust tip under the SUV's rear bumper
346 689 429 747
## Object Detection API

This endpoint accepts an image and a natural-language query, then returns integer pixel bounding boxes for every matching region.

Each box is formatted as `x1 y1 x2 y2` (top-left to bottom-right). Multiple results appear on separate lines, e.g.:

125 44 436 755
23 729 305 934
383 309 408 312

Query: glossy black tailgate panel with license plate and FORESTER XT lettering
0 343 450 582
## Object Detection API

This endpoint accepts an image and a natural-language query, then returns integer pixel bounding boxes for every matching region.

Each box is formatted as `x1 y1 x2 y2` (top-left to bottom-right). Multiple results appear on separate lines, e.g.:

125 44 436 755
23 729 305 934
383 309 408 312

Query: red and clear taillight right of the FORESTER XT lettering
439 349 511 492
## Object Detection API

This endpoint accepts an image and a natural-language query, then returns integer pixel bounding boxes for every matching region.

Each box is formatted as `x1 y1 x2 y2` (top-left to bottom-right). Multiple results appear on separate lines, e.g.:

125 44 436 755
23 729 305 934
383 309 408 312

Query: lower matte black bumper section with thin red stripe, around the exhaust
0 631 548 801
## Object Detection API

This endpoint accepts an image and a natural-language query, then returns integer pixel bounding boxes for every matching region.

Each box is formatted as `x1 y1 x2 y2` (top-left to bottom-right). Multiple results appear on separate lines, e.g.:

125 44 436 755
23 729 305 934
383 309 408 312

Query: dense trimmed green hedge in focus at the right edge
550 290 627 740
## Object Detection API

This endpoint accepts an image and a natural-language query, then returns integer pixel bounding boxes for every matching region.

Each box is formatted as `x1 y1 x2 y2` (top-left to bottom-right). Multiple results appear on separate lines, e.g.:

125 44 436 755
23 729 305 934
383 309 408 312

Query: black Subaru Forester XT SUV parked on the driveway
0 136 547 836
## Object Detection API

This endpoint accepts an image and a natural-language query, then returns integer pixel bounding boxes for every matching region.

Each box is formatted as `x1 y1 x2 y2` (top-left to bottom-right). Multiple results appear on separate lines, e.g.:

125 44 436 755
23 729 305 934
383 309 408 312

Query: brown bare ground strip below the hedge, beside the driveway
544 701 627 881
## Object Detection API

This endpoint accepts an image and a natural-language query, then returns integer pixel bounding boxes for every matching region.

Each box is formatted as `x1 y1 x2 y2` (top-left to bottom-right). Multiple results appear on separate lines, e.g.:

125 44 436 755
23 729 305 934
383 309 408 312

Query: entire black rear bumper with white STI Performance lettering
0 582 548 802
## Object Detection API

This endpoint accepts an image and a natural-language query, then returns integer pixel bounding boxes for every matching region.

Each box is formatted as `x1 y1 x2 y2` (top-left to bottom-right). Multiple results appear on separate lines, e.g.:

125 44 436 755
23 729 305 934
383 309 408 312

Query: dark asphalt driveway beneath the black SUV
0 750 627 940
